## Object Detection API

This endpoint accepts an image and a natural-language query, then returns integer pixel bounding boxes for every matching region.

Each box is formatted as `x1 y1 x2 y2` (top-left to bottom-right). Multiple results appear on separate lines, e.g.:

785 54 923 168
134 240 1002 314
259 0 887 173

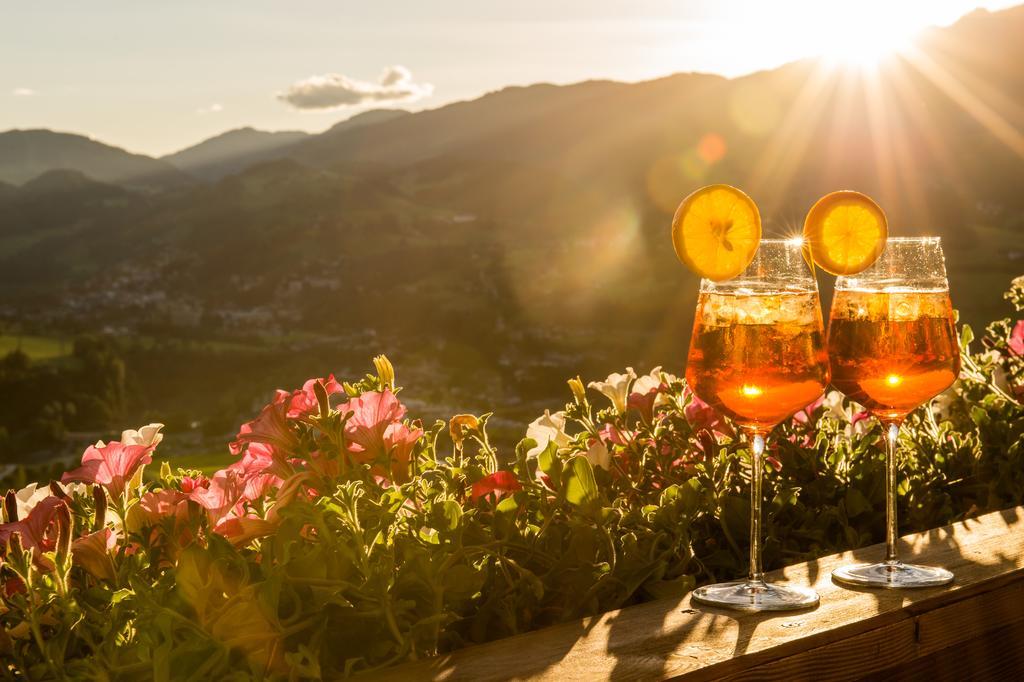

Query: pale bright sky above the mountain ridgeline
0 0 1020 156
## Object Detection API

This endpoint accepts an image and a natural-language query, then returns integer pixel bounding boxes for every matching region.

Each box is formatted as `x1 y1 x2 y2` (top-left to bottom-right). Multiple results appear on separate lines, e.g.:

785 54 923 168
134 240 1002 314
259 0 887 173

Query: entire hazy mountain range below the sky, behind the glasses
0 6 1024 425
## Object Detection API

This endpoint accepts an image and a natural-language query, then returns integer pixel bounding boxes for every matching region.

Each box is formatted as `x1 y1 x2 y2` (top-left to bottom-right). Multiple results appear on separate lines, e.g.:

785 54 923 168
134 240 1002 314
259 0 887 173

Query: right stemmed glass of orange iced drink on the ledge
828 237 961 588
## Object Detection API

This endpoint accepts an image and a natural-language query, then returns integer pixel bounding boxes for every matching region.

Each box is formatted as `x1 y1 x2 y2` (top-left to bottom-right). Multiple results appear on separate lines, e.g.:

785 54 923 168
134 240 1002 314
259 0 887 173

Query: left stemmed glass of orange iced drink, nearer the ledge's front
686 240 828 610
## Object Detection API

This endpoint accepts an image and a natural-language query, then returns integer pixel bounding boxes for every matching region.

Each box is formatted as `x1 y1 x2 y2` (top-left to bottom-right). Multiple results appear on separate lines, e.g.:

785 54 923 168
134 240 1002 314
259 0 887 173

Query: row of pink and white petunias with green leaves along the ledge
6 279 1024 680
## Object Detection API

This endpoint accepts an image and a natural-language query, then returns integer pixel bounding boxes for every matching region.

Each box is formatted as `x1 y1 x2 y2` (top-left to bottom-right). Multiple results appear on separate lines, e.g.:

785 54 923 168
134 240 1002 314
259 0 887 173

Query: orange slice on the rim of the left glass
672 184 761 282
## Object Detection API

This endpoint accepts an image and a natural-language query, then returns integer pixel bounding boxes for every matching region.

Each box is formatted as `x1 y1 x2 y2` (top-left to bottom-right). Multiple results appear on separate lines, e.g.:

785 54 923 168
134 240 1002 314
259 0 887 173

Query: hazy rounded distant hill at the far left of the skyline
0 130 191 189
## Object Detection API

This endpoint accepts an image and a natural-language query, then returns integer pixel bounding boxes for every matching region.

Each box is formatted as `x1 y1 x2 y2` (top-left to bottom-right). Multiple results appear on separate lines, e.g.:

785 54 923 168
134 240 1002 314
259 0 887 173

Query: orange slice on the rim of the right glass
804 189 889 274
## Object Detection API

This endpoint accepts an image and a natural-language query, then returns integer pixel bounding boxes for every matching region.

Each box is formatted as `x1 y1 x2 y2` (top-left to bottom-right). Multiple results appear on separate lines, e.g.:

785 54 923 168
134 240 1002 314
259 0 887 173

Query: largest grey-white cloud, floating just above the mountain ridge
278 66 434 110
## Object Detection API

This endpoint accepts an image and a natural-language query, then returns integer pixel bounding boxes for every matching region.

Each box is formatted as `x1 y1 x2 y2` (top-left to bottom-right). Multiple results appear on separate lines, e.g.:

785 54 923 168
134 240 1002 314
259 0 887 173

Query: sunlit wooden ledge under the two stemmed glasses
374 507 1024 680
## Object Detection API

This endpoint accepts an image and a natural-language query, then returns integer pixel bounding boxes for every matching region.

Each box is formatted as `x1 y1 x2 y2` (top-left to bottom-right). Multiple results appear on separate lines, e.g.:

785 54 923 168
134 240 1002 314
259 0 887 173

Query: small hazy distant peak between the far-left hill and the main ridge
161 128 308 180
